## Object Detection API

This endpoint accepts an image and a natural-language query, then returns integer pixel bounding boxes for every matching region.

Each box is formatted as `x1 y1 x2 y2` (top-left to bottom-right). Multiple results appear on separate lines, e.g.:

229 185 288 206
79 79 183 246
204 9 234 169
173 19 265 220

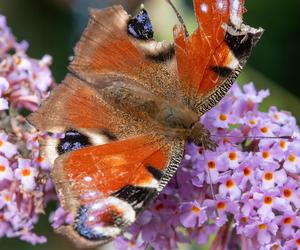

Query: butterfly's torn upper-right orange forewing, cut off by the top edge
174 0 263 114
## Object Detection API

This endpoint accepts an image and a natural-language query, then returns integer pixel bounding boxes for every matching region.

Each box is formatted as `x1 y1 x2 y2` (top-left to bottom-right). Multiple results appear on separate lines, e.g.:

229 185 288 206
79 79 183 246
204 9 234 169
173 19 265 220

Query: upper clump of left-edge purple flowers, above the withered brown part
0 16 54 111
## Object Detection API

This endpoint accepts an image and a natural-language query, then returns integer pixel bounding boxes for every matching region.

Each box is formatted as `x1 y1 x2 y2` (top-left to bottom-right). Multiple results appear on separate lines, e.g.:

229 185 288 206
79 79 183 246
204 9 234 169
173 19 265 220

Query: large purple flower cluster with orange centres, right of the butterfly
114 83 300 249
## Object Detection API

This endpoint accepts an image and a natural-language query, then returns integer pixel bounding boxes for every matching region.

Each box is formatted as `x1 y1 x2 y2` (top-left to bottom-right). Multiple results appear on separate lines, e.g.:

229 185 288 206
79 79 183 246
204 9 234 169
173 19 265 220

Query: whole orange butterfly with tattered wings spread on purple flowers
29 0 263 247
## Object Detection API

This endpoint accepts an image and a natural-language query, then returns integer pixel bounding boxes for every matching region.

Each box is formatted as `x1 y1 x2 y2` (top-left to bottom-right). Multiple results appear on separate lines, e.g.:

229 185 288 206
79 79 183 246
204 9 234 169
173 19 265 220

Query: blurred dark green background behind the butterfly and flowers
0 0 300 250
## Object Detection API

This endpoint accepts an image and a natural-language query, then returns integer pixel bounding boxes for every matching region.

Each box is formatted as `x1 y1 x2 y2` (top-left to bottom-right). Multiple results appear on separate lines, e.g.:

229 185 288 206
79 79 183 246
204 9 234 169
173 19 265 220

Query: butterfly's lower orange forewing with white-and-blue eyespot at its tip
52 135 183 246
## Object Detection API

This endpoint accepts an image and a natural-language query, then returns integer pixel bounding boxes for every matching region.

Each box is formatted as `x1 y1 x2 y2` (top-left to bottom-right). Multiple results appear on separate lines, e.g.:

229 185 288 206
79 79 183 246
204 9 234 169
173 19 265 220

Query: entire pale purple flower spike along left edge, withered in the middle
0 15 55 244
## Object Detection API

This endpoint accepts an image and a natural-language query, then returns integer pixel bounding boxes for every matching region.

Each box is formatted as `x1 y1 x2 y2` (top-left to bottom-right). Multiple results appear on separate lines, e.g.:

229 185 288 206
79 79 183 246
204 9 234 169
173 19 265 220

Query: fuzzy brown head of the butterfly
188 123 218 151
